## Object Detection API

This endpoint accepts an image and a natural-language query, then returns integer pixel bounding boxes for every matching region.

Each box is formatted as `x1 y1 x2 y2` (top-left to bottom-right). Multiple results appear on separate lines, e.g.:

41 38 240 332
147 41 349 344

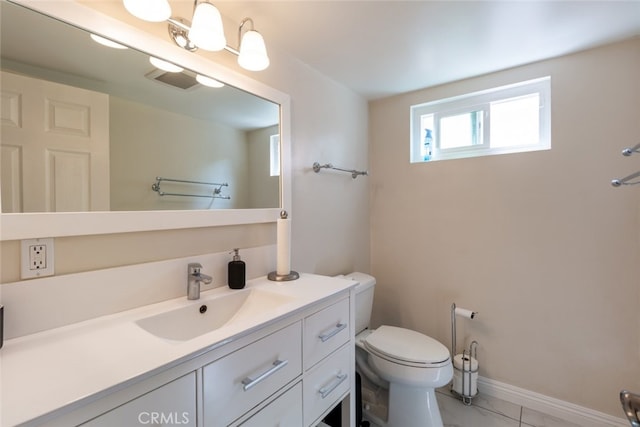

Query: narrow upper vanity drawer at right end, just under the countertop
304 298 350 369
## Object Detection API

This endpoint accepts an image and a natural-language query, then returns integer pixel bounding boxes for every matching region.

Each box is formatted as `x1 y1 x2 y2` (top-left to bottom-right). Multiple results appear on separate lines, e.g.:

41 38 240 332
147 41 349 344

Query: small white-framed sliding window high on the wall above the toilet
411 77 551 163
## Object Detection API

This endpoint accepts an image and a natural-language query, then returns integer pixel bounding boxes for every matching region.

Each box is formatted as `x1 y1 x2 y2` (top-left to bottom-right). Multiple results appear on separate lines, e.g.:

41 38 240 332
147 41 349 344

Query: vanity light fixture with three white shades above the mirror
123 0 269 71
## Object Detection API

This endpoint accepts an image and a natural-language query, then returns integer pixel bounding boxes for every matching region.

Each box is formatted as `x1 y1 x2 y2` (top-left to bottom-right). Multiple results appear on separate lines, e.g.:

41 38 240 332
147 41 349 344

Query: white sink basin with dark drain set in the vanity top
136 289 292 341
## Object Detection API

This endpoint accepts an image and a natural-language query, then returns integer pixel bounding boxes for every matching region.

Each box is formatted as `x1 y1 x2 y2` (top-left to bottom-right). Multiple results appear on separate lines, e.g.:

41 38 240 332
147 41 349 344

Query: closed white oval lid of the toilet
365 326 449 365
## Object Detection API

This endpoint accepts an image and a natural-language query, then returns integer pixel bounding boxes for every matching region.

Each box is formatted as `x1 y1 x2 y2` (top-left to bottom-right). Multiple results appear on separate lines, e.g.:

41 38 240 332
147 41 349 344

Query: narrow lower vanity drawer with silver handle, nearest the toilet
303 344 348 426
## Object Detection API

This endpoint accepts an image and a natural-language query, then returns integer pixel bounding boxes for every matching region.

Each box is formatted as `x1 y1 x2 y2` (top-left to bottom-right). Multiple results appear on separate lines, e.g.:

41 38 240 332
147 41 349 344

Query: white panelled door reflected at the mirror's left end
0 71 109 212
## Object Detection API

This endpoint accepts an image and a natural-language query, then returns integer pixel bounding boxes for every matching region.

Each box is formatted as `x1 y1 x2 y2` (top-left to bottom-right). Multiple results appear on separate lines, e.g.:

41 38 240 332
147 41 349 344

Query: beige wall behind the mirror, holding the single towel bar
0 0 369 283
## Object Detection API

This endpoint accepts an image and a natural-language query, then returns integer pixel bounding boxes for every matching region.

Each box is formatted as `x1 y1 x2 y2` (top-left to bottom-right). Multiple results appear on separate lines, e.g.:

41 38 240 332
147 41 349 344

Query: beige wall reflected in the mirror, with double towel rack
109 96 250 211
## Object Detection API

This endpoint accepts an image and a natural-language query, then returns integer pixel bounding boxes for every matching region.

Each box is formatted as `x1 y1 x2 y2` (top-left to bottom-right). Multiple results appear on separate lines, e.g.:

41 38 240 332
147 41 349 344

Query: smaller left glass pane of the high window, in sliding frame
439 111 483 149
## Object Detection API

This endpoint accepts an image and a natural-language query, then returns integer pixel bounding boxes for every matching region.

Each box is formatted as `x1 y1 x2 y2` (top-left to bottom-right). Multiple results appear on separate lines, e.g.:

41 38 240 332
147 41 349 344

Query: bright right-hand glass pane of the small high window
489 93 540 148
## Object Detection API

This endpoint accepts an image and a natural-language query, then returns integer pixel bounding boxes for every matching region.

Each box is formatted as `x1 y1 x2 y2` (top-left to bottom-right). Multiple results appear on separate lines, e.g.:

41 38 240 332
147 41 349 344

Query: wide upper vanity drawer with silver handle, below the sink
202 322 302 427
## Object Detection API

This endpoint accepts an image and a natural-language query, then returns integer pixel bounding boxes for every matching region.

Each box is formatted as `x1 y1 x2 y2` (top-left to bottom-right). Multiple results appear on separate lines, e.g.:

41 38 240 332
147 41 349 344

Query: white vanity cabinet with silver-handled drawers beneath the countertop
8 280 355 427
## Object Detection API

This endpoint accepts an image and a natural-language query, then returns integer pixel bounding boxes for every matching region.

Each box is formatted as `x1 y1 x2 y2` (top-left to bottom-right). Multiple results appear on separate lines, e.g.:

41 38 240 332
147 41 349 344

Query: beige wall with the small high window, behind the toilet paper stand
369 39 640 417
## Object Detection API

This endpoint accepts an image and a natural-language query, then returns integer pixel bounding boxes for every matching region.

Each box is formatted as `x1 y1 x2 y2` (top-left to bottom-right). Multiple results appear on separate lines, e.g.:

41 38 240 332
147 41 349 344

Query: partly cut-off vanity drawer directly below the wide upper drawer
233 382 302 427
